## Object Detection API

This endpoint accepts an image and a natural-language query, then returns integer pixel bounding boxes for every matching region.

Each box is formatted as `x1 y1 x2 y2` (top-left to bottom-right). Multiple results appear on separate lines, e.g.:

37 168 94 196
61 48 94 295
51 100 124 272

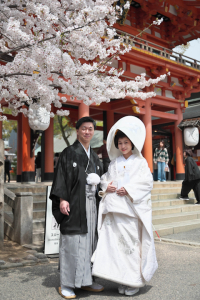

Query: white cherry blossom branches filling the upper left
0 0 166 118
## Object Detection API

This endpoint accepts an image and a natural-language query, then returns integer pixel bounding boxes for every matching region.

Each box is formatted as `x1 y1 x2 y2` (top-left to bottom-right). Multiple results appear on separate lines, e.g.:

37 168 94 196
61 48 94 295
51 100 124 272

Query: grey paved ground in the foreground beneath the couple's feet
0 242 200 300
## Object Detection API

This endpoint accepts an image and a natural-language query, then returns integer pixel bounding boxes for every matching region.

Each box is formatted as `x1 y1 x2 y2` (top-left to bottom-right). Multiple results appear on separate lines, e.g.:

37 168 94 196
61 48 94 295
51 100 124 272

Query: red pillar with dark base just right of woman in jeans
175 107 185 180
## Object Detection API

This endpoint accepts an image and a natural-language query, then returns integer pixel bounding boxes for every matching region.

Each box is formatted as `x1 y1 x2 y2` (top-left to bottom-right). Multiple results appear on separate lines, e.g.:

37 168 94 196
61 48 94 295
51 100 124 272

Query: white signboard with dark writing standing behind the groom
44 186 60 254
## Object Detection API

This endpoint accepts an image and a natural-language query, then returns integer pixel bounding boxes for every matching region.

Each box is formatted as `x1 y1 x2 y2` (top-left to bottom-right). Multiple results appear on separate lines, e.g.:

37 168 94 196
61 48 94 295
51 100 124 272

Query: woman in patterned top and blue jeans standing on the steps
153 140 169 182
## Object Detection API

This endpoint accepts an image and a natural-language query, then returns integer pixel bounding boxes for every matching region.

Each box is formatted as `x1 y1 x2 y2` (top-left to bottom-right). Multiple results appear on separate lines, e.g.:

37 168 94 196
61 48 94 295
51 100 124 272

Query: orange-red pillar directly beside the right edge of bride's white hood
143 99 153 173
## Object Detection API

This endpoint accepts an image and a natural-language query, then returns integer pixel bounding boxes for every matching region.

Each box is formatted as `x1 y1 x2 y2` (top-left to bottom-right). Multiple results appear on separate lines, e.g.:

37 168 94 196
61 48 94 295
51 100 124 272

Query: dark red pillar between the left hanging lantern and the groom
44 118 54 181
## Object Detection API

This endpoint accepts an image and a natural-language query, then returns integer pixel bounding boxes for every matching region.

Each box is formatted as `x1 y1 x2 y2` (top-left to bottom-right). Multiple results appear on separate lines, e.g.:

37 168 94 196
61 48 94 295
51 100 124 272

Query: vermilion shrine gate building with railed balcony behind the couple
0 0 200 182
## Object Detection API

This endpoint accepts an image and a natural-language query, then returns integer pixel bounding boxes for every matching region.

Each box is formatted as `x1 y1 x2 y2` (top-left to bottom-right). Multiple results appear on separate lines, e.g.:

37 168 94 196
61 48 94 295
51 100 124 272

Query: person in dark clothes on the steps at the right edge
179 149 200 205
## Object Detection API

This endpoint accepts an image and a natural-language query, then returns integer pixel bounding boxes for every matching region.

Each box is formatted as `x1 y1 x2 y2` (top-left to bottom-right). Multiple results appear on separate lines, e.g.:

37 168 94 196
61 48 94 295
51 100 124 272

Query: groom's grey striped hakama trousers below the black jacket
59 185 97 288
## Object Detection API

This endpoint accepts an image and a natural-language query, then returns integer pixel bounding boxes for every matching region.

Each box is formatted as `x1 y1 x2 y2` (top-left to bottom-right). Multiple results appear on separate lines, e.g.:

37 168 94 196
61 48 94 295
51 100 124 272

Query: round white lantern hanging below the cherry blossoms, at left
28 106 50 131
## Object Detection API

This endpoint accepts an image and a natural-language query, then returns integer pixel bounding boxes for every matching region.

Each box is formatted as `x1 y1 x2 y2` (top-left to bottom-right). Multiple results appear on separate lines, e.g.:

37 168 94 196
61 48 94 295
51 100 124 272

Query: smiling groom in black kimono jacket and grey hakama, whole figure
50 117 104 299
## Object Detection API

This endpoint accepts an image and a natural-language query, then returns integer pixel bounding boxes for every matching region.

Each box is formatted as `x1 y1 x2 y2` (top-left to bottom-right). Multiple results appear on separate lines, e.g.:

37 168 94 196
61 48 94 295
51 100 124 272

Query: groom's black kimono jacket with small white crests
50 140 103 234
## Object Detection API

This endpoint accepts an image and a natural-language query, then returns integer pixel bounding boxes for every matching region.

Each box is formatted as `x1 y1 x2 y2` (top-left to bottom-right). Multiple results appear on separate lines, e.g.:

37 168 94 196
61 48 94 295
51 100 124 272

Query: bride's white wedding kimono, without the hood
92 154 158 287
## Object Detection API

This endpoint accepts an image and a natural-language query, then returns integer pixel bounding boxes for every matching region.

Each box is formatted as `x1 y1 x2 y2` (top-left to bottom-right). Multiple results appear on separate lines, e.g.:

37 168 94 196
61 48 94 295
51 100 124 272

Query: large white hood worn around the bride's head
107 116 146 160
